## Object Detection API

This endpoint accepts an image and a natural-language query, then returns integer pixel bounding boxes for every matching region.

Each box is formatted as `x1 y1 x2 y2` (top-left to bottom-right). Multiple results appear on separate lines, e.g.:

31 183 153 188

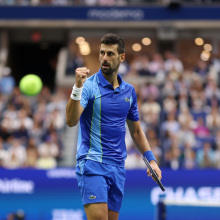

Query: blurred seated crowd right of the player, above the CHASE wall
124 52 220 169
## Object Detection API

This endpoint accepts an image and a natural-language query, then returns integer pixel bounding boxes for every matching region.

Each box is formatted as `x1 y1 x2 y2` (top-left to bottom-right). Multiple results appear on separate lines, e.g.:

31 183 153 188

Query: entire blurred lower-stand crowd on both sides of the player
0 48 220 169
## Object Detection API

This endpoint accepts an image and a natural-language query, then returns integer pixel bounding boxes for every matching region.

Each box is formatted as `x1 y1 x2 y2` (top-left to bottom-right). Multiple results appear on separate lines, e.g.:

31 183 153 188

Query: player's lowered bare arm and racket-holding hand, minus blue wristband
127 119 162 179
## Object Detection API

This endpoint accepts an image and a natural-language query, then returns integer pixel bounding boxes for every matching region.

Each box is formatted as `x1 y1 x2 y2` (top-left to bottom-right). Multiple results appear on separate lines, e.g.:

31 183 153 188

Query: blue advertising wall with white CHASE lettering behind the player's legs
0 168 220 220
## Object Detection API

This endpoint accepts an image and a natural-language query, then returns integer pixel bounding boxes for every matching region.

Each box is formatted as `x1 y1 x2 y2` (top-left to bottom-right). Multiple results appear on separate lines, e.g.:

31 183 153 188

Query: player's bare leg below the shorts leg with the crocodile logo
84 203 108 220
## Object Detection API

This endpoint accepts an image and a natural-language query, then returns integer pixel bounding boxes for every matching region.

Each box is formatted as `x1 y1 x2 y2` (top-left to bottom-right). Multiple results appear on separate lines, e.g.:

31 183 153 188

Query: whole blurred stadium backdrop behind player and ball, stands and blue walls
0 0 220 220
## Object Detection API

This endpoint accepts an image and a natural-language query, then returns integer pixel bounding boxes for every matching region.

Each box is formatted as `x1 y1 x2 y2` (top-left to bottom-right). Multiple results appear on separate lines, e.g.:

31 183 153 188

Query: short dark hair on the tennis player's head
101 33 125 54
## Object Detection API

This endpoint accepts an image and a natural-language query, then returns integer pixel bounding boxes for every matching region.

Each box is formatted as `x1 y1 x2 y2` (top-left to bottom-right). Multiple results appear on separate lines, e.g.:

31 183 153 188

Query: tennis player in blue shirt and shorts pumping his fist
66 33 161 220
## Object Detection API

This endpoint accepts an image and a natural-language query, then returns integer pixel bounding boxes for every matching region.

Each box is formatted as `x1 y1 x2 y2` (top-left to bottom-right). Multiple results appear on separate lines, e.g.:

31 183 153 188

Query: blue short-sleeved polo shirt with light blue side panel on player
77 69 139 166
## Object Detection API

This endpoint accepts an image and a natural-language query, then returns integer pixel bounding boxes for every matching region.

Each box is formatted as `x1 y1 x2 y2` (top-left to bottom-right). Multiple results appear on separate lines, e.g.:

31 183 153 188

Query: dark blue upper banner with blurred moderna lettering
0 5 220 21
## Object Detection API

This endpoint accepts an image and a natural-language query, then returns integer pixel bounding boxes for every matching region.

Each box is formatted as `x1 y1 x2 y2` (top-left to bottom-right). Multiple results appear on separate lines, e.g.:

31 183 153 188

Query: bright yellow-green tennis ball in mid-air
19 74 43 96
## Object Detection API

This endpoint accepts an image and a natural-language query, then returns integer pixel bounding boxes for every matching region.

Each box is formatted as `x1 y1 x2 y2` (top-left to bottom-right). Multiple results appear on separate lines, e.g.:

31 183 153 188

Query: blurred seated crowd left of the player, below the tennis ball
0 69 67 169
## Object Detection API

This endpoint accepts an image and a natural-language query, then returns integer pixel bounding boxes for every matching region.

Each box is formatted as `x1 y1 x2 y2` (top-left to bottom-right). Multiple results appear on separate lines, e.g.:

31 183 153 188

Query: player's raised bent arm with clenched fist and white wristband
66 67 89 127
